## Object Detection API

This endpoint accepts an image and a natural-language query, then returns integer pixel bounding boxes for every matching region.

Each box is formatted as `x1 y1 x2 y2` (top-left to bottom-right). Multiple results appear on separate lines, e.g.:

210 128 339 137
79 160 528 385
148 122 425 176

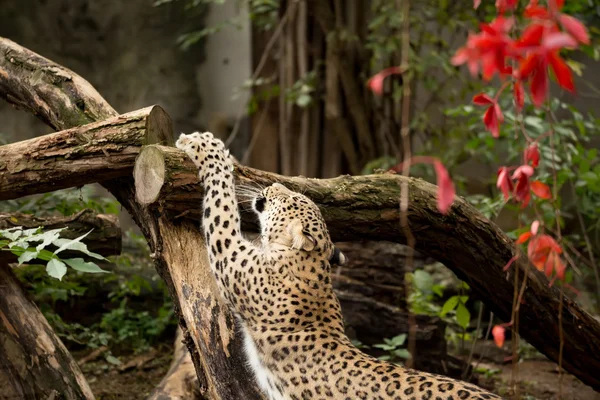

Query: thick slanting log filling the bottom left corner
0 262 94 400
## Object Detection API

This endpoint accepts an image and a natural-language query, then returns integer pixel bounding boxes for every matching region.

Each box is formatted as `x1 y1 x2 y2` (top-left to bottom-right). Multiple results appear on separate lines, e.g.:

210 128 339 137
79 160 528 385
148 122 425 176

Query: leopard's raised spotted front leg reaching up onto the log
176 132 265 322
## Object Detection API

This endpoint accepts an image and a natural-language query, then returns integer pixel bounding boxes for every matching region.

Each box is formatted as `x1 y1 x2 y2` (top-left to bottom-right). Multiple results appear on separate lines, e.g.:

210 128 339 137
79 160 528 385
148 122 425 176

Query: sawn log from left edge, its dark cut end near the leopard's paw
0 104 173 200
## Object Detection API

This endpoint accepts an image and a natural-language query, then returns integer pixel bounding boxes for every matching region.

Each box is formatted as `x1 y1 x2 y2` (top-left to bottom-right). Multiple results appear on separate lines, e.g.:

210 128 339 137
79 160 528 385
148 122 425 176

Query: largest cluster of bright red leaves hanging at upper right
452 0 590 119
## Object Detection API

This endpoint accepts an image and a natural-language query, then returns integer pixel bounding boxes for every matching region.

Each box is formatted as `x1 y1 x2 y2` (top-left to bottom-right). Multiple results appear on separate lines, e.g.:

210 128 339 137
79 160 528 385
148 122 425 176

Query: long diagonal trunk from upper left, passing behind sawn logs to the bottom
0 38 261 400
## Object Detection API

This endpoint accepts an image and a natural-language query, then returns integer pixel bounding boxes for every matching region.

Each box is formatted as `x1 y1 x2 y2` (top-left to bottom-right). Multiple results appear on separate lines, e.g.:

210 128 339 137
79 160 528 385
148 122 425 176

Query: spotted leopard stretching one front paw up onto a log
176 132 501 400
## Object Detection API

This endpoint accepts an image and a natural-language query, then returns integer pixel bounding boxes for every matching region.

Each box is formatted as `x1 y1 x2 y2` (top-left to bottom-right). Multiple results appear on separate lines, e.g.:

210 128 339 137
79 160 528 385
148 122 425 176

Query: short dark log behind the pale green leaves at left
0 210 122 263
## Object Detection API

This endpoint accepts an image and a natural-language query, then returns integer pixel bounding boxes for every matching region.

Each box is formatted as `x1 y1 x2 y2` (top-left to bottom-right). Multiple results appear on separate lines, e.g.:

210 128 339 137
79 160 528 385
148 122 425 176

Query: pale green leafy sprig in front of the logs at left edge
0 226 107 280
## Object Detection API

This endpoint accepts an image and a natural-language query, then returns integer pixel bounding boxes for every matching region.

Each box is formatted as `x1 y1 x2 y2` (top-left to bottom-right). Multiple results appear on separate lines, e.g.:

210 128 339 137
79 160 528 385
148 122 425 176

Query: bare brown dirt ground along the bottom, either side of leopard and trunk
75 345 600 400
